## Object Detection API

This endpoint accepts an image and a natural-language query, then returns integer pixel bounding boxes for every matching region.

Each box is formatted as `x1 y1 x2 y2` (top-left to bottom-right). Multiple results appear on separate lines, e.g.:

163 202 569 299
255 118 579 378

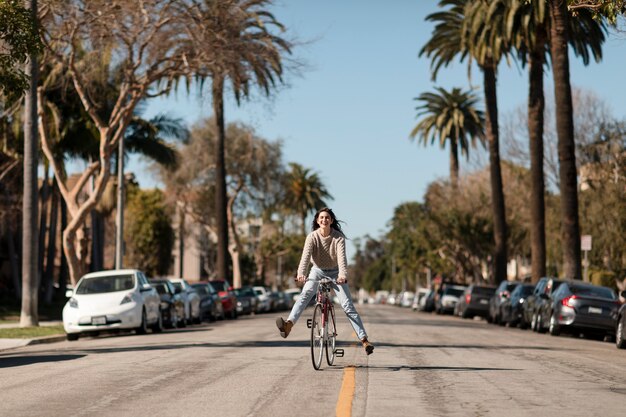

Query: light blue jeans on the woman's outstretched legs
287 266 367 340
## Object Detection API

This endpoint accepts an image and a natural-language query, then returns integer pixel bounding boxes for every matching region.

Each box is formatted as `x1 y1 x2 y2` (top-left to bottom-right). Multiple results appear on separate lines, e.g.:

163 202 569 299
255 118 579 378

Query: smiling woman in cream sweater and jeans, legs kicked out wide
276 207 374 355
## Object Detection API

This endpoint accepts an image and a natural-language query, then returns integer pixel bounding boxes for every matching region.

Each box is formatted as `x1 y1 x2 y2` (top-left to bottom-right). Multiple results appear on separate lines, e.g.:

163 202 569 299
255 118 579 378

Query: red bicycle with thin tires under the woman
307 278 344 371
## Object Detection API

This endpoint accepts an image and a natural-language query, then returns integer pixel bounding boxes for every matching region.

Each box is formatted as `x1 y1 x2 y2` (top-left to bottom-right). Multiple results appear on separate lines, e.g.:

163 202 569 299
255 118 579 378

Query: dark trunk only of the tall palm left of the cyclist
212 77 229 279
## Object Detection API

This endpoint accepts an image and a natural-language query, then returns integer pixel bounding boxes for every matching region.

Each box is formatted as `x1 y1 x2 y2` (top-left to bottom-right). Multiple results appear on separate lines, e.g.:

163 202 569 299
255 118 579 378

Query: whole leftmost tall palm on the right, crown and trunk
420 0 509 282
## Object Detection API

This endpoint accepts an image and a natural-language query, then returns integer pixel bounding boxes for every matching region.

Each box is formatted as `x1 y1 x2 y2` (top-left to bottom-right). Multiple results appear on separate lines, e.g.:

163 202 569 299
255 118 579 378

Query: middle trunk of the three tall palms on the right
528 27 546 283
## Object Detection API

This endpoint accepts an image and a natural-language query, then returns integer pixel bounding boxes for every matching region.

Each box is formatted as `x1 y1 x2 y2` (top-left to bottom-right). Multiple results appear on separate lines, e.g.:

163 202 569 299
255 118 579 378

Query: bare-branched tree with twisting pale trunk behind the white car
38 0 188 284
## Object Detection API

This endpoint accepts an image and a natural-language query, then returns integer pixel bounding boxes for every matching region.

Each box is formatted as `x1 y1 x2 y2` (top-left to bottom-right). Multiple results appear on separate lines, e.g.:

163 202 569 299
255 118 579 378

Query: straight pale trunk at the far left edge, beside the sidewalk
20 0 39 327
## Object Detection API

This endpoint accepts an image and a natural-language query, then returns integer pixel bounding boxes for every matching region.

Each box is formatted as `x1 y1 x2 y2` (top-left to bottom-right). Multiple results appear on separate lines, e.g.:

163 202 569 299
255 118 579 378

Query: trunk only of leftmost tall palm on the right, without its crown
483 66 507 283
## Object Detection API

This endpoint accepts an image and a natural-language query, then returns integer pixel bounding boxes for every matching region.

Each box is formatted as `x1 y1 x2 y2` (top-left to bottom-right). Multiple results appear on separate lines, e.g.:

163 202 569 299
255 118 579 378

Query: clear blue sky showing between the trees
136 0 626 257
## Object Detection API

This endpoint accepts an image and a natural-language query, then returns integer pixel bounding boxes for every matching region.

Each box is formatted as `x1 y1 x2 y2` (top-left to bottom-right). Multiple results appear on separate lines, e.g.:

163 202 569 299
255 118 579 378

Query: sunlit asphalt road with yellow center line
0 305 626 417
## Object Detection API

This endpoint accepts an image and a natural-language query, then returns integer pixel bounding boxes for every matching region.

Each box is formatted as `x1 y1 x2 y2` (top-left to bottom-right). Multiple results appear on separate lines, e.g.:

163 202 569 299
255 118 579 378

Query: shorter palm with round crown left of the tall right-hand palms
411 87 485 187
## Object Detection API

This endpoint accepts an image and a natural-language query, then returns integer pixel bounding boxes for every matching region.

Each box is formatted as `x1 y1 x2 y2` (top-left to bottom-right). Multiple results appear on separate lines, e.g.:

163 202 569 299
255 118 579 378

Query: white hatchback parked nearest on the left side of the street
63 269 163 340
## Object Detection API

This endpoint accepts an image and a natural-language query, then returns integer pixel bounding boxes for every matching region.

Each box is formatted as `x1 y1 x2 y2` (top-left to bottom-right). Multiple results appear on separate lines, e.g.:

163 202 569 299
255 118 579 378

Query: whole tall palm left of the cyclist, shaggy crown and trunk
178 0 291 277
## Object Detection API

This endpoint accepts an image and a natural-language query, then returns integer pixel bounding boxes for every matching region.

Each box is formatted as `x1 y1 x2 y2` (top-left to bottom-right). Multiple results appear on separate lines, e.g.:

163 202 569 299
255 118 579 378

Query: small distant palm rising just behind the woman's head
285 162 333 235
